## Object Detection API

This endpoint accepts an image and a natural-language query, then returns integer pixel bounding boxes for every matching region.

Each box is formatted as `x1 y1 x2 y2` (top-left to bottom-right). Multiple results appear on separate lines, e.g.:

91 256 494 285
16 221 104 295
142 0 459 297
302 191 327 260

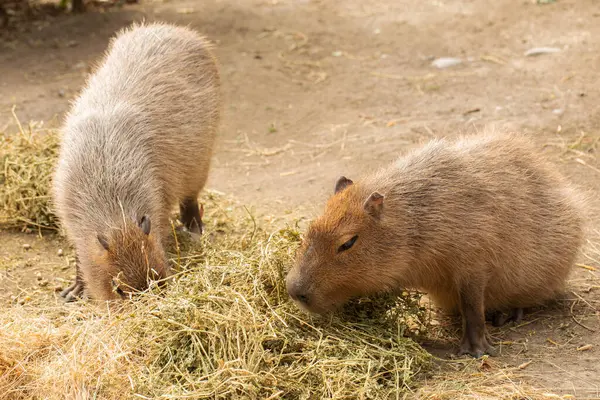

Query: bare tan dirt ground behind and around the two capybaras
0 0 600 399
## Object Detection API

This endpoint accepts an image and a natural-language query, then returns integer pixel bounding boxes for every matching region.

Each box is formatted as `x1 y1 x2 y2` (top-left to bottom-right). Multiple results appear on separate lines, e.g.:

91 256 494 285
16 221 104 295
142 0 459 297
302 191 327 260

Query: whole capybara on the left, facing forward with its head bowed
54 24 221 300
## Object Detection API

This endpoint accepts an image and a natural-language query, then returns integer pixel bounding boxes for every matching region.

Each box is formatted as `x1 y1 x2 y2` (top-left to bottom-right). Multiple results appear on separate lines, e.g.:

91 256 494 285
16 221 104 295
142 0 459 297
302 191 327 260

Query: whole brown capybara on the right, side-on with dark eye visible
286 133 584 357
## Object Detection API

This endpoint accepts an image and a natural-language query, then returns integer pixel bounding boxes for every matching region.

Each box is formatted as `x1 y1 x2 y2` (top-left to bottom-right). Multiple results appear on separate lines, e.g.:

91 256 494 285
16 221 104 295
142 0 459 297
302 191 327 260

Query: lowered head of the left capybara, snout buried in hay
87 215 170 300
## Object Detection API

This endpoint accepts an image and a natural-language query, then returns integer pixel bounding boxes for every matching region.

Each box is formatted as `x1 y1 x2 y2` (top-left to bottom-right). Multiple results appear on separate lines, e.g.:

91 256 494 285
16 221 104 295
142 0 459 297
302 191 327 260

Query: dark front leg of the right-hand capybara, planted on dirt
458 287 495 358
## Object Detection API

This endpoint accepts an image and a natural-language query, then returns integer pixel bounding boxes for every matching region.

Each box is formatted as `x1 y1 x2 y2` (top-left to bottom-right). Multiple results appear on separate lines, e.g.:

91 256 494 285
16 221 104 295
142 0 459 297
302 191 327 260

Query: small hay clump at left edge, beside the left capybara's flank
0 119 59 230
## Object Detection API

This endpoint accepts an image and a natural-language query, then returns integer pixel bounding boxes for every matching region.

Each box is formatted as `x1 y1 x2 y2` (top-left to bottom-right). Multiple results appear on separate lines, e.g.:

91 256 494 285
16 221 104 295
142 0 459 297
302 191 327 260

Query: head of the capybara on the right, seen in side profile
286 177 402 314
